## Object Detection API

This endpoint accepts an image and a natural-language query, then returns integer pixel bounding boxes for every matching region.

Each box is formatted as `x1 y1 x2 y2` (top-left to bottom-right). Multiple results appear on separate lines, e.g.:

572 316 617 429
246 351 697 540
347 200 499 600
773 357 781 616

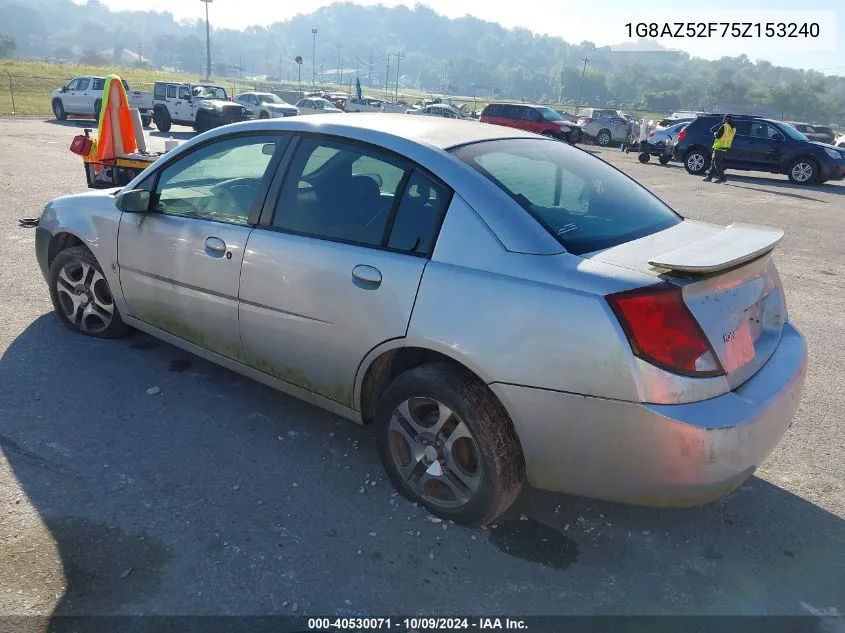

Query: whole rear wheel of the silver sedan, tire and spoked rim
375 363 525 525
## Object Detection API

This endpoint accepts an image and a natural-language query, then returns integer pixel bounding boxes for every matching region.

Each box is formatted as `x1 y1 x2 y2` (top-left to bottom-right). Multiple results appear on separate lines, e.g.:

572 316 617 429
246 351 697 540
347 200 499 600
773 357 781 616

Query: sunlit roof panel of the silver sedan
203 112 539 150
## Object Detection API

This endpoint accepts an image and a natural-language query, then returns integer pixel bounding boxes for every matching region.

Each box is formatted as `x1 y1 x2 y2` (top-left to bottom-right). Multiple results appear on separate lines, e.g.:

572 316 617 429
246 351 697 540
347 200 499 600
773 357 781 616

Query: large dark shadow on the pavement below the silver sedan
0 313 845 616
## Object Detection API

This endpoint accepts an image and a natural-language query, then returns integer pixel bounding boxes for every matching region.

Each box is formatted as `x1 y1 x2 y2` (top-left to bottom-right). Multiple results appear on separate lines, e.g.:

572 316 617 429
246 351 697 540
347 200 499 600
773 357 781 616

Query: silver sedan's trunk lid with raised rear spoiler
584 220 787 389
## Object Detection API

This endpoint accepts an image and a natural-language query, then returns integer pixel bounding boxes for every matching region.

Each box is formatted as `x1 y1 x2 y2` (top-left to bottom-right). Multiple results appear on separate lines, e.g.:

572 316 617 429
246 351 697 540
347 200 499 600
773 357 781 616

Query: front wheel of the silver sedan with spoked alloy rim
50 246 131 338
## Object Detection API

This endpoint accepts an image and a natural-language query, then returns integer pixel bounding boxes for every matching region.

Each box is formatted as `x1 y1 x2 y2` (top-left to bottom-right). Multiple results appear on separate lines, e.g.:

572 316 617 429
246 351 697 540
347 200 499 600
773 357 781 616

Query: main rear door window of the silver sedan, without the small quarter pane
273 138 405 246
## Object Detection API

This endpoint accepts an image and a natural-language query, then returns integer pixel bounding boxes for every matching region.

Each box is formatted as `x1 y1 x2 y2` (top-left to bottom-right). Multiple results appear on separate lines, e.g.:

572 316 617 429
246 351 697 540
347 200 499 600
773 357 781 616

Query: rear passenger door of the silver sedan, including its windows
239 137 449 408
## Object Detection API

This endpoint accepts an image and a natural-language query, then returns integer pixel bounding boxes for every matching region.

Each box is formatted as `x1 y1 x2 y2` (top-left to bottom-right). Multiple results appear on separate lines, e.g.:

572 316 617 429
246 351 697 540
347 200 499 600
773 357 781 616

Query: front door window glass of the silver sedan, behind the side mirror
154 135 284 224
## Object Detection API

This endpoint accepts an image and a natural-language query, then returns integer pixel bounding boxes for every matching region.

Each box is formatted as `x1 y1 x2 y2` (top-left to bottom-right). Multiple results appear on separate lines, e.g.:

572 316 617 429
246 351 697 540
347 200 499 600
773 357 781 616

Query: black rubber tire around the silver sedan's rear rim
375 363 525 526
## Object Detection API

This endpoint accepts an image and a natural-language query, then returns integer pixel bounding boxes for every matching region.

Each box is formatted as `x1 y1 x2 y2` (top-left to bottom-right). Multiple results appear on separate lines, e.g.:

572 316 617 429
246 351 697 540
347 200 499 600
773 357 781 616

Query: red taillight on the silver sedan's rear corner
607 284 725 378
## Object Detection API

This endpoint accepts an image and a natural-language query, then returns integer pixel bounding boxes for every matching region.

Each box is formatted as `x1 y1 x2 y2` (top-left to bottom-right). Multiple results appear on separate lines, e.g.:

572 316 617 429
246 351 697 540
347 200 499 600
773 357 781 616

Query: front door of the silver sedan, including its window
118 133 289 360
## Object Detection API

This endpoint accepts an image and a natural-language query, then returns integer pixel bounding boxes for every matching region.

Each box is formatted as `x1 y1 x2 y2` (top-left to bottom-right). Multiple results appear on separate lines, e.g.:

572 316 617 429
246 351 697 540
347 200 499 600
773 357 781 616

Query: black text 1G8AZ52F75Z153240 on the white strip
625 22 821 39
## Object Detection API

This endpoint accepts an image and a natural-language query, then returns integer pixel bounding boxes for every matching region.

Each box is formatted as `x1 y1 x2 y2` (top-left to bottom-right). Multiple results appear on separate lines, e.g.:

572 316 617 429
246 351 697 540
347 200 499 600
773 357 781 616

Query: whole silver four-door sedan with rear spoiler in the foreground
36 114 806 525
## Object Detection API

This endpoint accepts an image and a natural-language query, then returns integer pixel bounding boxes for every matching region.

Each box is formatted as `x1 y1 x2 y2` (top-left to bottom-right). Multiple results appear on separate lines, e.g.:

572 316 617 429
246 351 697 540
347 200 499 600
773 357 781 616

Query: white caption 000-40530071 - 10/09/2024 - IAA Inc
308 617 528 631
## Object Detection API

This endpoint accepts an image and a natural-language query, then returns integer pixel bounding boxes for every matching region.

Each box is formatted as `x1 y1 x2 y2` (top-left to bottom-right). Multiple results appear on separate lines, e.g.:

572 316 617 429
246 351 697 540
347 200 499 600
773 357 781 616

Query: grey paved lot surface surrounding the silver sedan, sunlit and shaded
0 115 845 616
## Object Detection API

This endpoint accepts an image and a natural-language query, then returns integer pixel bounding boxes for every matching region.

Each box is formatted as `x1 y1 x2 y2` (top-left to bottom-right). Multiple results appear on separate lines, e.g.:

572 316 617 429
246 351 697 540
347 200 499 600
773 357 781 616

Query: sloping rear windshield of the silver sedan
453 139 682 255
